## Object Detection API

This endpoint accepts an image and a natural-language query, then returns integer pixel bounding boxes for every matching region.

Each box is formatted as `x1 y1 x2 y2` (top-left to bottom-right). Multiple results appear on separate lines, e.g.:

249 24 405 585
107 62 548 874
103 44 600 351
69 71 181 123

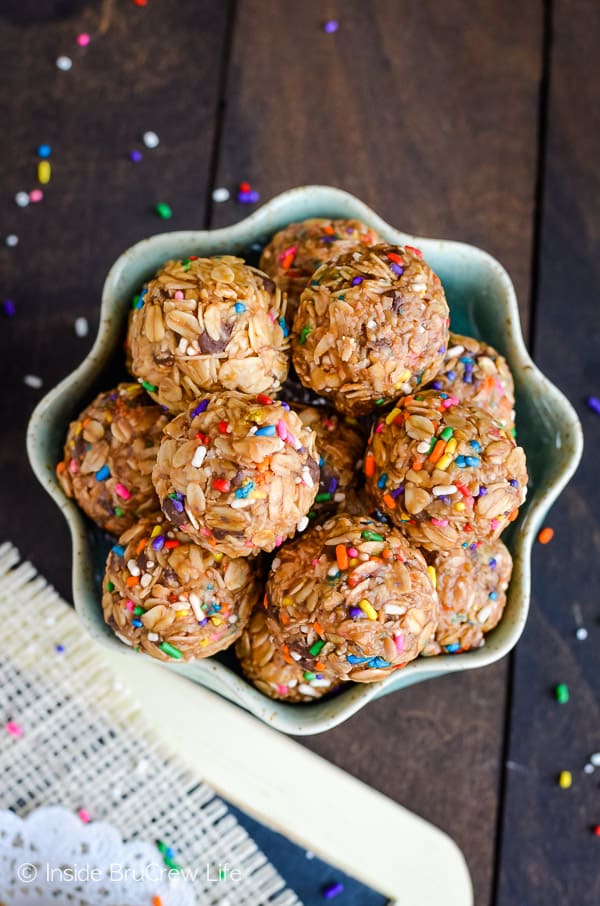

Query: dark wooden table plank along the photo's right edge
497 0 600 906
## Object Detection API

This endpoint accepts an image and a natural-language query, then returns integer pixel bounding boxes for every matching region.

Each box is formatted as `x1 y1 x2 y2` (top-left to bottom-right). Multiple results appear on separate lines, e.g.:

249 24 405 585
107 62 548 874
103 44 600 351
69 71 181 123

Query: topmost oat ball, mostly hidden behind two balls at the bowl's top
260 217 381 324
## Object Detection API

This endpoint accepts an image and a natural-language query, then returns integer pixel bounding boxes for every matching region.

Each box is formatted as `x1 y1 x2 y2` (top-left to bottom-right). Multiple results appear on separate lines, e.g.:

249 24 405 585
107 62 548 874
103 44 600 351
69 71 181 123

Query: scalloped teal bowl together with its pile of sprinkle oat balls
28 186 582 734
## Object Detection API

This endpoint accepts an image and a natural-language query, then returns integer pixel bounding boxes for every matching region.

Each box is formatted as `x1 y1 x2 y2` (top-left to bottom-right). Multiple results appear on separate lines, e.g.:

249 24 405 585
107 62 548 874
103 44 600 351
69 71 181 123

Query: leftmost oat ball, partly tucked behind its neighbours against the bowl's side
56 384 169 535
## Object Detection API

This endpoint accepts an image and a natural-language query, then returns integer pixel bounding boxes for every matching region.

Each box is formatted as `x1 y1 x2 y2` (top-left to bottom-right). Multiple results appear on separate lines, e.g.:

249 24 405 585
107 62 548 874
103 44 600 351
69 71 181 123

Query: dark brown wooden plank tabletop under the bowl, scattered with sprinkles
0 0 600 906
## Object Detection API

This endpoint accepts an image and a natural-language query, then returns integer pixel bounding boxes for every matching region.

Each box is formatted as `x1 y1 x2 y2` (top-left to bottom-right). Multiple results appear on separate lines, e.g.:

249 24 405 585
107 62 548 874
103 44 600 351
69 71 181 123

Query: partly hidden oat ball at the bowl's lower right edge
423 541 512 655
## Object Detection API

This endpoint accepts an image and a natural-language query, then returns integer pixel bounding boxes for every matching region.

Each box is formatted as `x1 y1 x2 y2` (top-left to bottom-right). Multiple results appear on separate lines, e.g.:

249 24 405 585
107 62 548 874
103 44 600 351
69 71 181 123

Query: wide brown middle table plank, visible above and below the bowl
213 0 542 906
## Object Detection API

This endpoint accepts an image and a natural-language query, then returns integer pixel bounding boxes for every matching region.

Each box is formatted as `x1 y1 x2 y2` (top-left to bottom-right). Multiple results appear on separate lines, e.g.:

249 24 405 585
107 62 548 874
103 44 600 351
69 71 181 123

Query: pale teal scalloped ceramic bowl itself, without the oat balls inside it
27 186 583 734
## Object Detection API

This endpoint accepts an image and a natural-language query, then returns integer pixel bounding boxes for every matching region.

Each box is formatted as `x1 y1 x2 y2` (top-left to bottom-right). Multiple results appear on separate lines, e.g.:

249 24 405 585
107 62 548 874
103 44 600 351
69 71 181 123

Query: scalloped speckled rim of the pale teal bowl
27 186 583 735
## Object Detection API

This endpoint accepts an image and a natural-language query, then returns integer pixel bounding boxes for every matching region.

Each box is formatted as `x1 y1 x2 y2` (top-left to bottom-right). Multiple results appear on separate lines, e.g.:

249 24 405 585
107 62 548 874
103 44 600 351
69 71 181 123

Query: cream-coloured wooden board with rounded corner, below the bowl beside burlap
106 648 473 906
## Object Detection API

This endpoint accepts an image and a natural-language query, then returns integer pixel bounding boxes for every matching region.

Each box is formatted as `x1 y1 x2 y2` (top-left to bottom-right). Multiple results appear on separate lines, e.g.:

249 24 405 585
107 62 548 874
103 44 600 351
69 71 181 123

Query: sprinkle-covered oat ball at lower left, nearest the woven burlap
102 513 262 661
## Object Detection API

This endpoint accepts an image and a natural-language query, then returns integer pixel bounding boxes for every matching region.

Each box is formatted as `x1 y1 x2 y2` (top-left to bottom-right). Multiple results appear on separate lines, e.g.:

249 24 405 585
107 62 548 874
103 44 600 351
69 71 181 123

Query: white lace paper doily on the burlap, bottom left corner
0 806 196 906
